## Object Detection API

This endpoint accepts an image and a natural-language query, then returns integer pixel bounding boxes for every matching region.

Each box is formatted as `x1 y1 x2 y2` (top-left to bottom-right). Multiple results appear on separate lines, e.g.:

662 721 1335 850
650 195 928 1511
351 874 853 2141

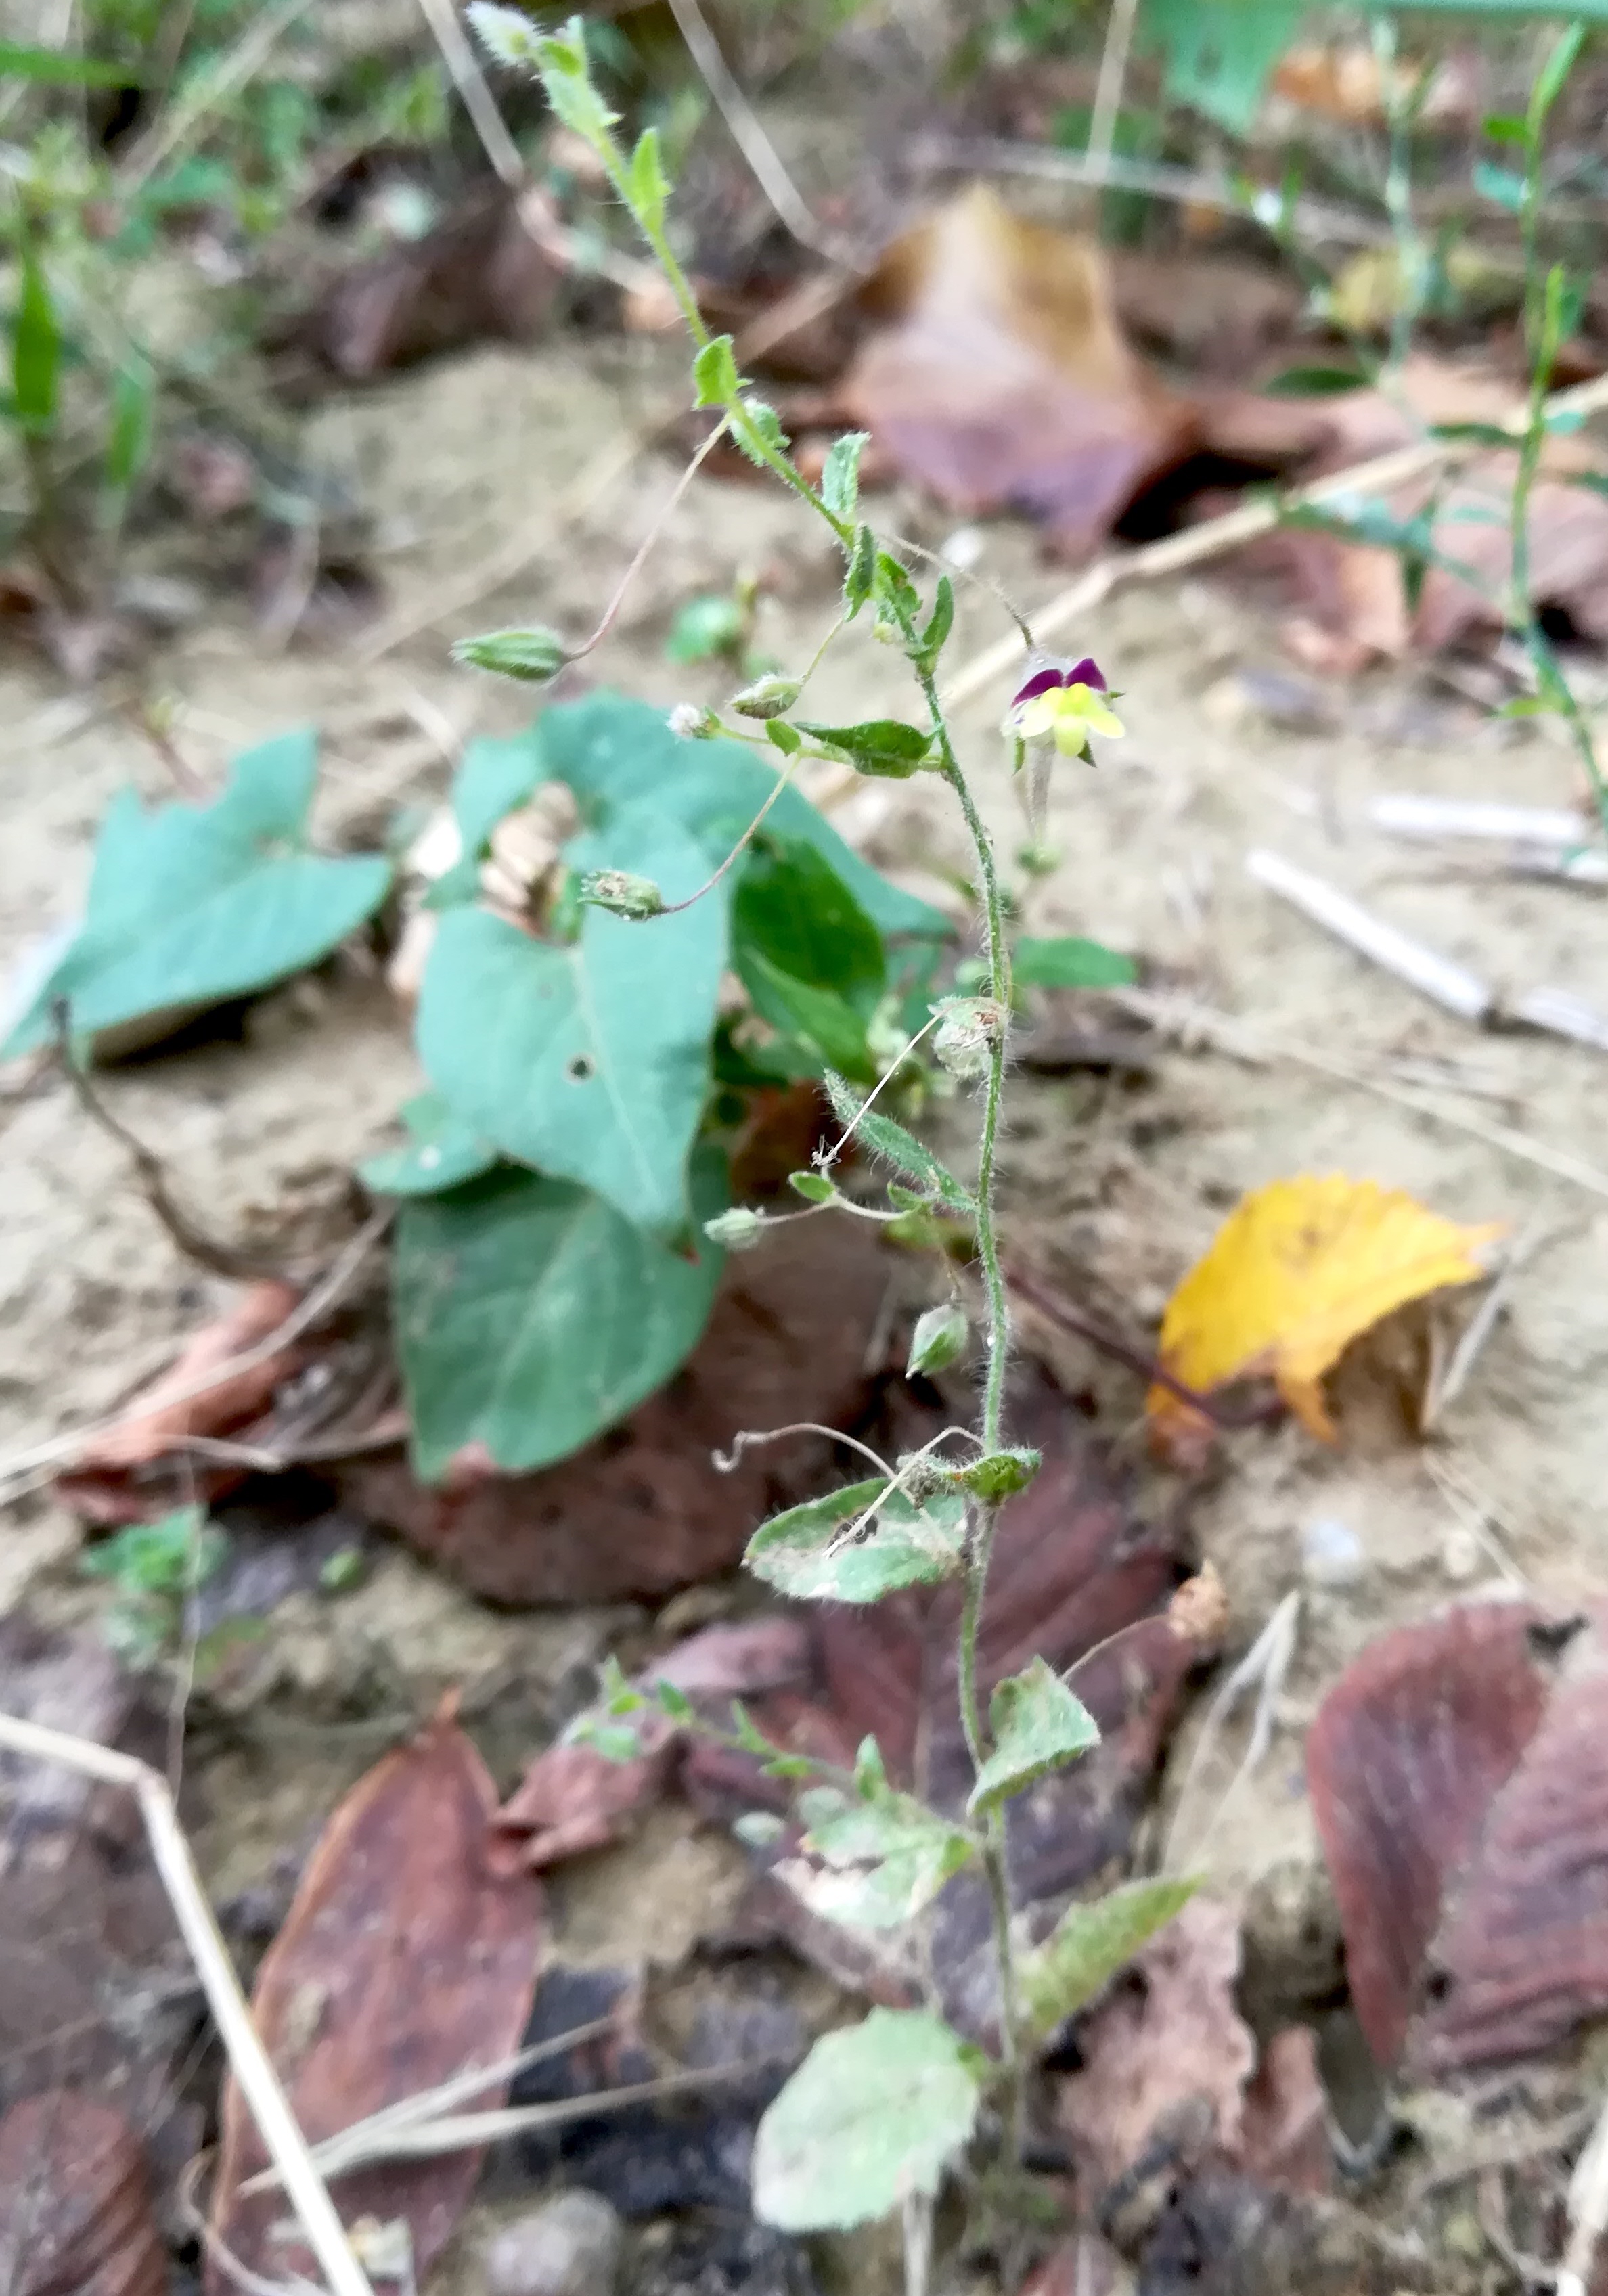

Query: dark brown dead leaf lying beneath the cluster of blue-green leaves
340 1219 889 1602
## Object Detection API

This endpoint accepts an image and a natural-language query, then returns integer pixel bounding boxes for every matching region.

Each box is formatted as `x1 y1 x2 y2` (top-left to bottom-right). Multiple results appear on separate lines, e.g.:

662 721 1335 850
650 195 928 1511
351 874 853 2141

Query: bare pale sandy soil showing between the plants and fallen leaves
0 344 1608 2287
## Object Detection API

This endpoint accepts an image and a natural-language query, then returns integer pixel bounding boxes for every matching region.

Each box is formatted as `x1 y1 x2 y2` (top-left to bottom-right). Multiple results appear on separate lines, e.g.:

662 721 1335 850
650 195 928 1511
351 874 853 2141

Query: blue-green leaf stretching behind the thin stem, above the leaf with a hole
533 694 954 941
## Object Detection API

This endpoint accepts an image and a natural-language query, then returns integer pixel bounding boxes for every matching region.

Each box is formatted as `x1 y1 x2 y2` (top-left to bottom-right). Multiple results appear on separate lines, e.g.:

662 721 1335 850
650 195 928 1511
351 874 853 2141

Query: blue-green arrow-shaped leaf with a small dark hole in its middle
418 811 728 1233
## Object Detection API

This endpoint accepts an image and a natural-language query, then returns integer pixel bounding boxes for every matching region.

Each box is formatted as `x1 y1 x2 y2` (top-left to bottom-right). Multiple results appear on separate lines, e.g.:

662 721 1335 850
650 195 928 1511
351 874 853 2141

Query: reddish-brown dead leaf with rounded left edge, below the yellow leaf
1307 1602 1548 2067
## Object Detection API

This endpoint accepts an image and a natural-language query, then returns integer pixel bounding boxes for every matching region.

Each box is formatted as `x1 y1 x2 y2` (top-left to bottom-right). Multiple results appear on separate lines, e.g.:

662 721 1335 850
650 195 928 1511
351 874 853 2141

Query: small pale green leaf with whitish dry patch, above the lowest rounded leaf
783 1784 977 1929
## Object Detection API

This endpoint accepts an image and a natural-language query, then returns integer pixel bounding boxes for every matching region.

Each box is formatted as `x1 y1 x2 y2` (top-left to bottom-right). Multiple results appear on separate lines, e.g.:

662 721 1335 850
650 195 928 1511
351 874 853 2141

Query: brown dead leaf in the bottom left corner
0 2090 168 2296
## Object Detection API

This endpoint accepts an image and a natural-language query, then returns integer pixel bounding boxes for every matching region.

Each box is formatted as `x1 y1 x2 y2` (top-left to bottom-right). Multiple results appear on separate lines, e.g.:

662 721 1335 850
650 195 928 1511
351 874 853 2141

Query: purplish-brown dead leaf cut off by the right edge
1406 1609 1608 2078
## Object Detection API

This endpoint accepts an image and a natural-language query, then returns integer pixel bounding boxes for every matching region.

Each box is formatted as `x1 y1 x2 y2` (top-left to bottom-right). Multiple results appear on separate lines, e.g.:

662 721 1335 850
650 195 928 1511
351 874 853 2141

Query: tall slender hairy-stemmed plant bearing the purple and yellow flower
445 13 1190 2284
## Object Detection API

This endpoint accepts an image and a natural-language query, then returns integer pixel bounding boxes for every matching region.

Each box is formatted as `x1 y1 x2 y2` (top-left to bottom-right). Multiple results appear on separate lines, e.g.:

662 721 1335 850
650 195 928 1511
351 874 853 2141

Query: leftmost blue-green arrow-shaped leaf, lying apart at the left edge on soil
0 732 390 1058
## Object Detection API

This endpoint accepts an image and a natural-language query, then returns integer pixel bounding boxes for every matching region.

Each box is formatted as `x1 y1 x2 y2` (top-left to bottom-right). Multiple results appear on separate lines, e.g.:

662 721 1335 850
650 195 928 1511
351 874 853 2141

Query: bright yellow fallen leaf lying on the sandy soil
1148 1173 1502 1442
